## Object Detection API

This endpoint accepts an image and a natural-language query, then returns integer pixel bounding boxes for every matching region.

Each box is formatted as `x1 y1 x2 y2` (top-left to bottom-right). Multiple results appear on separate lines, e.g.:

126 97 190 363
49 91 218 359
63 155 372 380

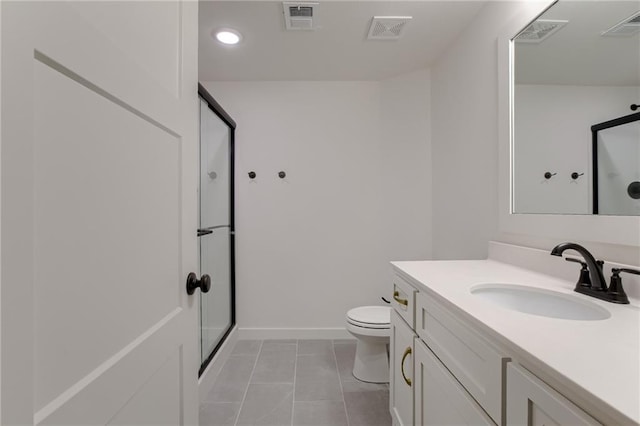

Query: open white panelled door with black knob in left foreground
0 0 199 425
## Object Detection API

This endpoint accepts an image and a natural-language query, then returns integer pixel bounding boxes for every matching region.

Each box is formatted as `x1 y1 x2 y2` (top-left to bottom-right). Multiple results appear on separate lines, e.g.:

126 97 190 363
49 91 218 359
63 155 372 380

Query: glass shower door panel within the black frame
198 98 234 374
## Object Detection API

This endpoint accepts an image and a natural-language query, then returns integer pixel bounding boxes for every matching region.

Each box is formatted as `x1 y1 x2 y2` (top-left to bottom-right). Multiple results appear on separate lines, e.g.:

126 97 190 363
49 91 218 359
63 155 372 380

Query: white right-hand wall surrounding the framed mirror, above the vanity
431 1 640 265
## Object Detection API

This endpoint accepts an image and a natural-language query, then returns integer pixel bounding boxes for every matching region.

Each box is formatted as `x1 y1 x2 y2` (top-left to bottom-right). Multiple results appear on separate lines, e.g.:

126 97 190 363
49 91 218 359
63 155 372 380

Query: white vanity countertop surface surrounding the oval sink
392 260 640 424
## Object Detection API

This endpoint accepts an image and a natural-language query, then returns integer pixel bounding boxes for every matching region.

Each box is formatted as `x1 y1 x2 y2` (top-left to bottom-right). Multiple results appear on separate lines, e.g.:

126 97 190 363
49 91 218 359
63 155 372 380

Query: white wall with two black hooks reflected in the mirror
514 84 638 214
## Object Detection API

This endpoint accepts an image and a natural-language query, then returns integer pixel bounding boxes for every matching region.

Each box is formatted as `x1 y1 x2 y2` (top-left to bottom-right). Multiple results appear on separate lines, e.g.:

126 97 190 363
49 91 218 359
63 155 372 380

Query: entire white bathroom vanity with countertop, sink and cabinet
390 243 640 425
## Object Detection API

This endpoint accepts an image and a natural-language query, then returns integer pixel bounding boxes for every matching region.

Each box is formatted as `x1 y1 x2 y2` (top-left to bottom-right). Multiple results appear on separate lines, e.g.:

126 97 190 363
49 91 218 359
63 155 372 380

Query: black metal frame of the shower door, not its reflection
198 83 236 378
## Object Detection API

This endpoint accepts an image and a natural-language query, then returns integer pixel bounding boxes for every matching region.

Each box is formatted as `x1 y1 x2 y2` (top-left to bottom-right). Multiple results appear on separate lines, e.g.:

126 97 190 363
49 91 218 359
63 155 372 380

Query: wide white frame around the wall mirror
498 0 640 247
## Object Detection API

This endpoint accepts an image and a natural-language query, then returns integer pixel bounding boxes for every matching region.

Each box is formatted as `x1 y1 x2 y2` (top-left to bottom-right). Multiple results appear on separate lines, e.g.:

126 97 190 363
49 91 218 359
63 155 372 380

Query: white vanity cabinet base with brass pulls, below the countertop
389 270 600 426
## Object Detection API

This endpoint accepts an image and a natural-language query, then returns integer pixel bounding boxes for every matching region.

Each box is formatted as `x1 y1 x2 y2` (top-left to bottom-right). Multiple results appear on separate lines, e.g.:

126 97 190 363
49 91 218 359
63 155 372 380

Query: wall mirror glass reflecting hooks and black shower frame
511 0 640 216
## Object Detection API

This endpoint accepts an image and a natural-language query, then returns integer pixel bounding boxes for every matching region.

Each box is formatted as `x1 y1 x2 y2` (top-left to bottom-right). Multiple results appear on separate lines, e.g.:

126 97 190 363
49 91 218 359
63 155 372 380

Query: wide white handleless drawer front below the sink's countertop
415 293 508 424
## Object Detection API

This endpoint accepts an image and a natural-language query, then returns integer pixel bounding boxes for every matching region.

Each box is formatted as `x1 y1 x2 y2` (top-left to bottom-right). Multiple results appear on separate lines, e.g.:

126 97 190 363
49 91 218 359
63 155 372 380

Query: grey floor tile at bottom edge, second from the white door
237 383 293 426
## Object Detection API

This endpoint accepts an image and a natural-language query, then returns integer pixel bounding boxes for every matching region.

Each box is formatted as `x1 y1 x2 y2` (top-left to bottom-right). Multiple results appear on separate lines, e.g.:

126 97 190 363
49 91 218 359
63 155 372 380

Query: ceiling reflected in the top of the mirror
515 0 640 86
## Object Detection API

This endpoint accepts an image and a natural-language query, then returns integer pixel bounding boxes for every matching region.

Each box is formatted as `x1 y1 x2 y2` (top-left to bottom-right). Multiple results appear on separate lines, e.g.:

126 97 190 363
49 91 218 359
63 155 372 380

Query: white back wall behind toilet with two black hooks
204 77 431 335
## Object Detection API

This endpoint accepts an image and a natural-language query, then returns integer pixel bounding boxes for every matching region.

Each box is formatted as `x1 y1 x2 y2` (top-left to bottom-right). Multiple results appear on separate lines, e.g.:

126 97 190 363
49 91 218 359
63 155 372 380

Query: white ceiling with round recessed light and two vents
199 0 484 81
